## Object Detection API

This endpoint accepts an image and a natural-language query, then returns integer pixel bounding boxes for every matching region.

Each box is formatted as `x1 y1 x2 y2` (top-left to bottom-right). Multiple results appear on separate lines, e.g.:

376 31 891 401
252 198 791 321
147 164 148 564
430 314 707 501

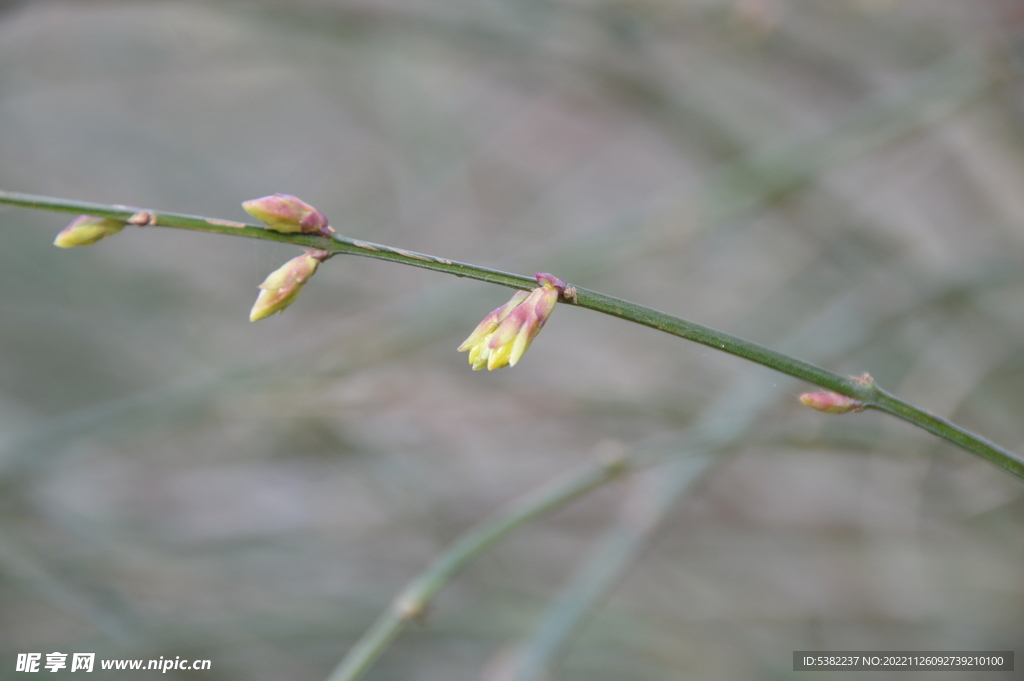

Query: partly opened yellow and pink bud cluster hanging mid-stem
459 273 566 371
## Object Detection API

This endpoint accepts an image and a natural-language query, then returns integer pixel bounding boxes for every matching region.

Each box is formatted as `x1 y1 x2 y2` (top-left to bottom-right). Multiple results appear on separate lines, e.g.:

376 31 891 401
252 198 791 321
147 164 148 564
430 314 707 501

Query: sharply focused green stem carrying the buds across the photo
0 190 1024 479
